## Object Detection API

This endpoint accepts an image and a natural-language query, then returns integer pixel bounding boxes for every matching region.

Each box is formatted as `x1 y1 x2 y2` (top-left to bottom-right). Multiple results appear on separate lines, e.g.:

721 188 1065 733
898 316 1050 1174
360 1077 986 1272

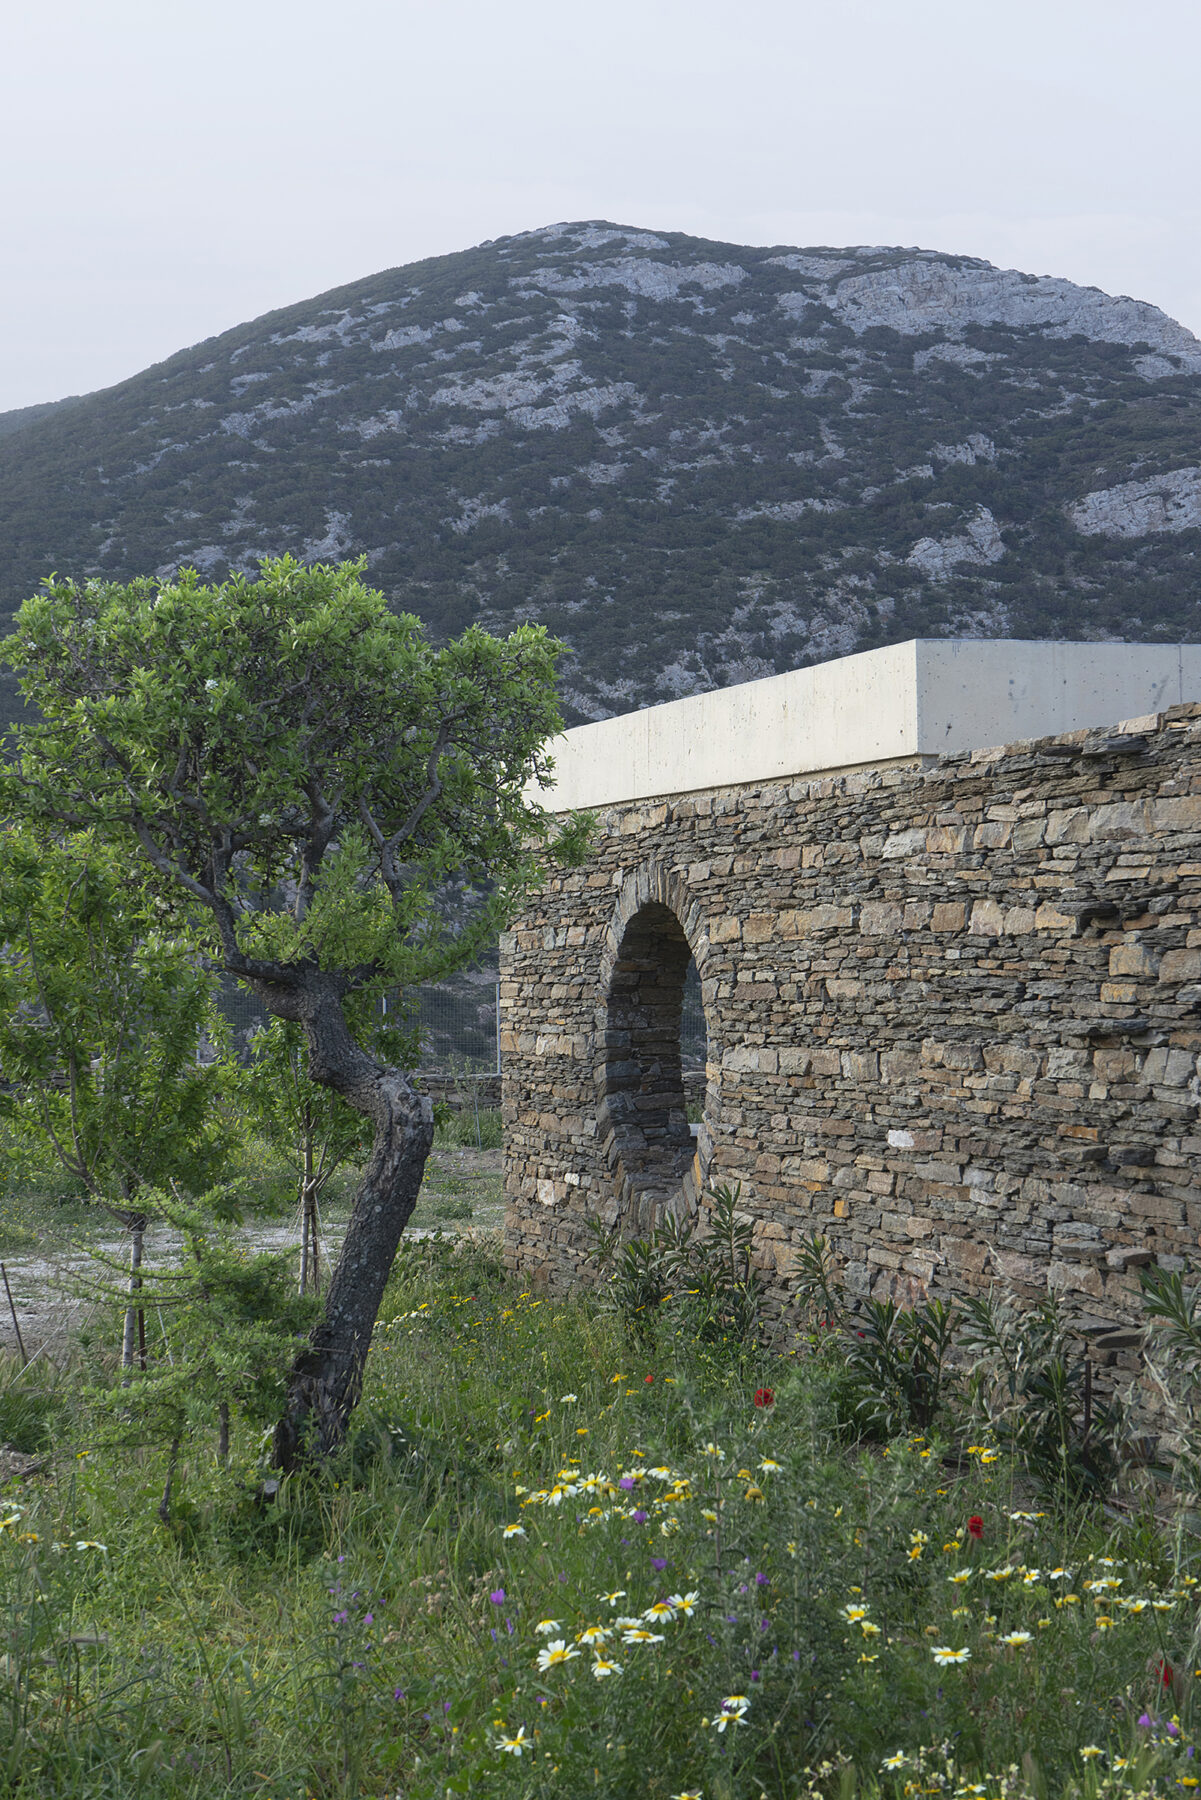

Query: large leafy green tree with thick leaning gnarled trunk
7 556 576 1469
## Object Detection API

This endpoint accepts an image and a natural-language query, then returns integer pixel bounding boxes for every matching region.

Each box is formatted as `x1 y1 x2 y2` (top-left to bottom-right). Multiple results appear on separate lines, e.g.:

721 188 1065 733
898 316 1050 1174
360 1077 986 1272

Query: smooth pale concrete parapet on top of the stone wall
529 637 1201 812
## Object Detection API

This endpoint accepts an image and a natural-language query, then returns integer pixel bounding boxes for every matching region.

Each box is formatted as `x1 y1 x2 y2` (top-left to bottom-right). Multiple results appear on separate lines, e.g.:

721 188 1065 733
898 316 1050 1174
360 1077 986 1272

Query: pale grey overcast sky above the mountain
0 0 1201 410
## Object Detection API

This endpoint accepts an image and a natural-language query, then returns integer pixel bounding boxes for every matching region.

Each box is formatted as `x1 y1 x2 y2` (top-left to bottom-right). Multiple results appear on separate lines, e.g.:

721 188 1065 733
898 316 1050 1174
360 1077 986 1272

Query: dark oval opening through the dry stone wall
600 902 704 1229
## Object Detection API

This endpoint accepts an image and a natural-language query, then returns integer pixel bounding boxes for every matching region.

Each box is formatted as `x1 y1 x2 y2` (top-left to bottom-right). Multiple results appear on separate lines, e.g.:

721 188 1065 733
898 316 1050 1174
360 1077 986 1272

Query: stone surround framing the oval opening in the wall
596 862 720 1233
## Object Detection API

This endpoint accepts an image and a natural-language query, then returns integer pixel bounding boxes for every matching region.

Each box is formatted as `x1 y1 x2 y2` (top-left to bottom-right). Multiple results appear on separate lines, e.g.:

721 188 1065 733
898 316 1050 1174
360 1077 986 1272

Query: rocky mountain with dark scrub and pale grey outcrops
0 223 1201 718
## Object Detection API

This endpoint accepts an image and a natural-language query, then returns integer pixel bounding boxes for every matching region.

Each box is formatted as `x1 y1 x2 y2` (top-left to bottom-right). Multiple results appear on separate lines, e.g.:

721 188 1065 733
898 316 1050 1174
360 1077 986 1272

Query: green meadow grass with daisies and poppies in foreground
0 1237 1197 1800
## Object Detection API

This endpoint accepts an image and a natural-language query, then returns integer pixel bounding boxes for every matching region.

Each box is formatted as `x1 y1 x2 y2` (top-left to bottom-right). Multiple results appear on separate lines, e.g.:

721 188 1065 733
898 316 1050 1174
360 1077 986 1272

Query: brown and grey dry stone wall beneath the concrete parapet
501 706 1201 1353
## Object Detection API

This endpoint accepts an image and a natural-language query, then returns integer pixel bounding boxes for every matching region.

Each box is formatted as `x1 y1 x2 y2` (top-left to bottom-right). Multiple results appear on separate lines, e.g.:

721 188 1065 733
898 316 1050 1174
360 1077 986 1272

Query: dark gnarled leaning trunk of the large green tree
263 972 434 1471
